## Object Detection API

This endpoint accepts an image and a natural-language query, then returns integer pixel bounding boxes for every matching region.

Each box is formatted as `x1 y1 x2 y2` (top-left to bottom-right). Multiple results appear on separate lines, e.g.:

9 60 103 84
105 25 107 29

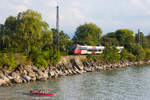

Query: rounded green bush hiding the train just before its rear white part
103 47 120 62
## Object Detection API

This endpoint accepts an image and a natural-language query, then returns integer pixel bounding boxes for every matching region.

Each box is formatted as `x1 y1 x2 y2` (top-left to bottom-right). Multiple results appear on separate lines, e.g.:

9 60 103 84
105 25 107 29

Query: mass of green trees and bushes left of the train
0 10 71 69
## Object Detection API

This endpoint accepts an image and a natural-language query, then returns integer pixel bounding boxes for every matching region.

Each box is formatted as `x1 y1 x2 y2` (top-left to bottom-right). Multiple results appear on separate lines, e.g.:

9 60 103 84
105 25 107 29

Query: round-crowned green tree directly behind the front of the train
73 23 102 45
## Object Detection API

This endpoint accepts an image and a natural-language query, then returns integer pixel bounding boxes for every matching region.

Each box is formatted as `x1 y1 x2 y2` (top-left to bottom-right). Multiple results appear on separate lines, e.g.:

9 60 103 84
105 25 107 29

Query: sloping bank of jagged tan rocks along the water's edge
0 56 150 87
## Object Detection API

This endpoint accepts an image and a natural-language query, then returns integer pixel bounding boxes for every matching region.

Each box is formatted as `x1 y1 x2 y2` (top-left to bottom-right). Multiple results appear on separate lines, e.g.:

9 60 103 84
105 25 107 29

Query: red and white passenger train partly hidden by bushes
72 44 124 54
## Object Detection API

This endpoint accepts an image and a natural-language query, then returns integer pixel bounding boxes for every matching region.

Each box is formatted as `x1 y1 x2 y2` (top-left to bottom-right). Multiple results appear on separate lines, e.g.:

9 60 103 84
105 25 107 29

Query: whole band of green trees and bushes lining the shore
0 9 150 69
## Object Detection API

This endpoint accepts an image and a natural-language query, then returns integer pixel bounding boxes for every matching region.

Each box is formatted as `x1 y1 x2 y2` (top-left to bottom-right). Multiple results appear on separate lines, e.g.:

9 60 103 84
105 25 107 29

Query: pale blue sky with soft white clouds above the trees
0 0 150 37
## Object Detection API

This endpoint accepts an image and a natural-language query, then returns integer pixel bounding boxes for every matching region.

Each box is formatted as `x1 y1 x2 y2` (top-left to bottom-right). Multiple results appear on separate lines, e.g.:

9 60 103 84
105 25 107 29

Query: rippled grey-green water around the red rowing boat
0 66 150 100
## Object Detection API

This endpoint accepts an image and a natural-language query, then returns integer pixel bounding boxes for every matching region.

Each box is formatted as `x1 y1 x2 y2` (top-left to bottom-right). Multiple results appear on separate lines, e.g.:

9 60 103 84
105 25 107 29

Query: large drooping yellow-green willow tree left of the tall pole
1 10 52 53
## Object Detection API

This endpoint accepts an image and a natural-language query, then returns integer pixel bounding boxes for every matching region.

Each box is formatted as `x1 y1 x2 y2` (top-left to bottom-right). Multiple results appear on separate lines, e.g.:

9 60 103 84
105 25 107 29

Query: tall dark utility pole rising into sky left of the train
56 6 59 48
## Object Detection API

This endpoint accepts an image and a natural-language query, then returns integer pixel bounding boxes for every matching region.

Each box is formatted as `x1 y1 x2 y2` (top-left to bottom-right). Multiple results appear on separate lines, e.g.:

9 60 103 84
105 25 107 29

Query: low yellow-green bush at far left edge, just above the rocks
0 53 18 70
